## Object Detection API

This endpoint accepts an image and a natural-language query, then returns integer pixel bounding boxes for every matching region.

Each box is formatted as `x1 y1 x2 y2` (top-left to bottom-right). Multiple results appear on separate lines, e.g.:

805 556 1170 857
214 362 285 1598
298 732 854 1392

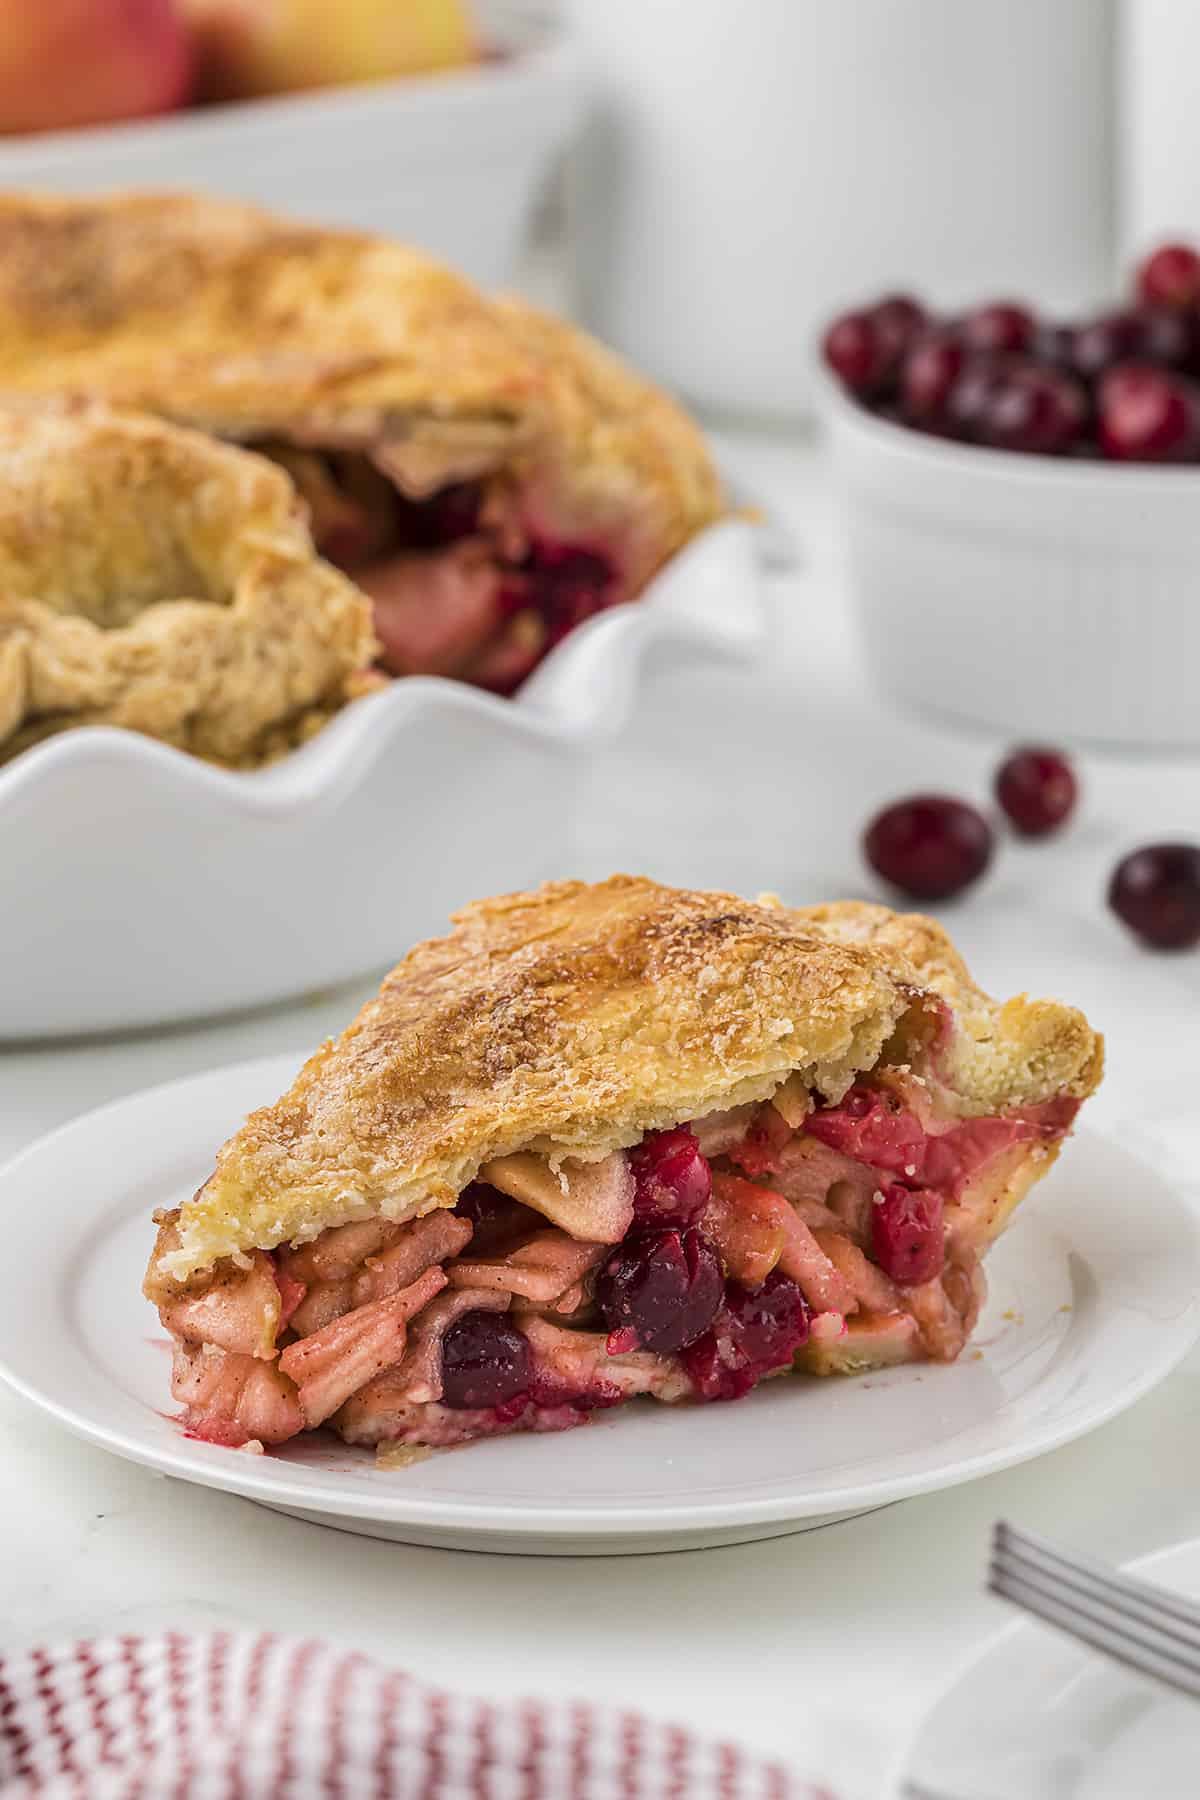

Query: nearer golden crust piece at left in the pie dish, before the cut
0 401 376 765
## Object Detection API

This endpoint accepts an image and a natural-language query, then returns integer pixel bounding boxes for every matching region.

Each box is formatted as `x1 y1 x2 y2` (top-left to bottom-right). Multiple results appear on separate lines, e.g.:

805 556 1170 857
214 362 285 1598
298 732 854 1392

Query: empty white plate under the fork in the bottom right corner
898 1539 1200 1800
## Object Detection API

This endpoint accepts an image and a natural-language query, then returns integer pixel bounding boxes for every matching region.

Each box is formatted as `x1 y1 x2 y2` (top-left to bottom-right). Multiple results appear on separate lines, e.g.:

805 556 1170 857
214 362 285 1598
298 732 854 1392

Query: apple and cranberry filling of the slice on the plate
151 1066 1078 1445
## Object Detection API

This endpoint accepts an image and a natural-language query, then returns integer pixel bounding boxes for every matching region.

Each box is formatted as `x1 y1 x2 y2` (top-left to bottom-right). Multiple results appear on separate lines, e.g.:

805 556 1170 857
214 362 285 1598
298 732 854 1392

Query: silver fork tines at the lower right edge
988 1528 1200 1699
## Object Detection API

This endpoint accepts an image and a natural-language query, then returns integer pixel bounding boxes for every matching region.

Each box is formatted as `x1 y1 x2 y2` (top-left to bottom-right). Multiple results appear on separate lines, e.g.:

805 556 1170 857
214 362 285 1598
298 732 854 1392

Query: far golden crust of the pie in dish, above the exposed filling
0 194 723 585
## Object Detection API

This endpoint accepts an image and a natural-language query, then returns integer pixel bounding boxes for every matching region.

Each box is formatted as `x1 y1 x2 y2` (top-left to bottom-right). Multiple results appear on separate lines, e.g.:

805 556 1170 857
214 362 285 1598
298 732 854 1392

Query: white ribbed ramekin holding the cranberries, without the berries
828 392 1200 749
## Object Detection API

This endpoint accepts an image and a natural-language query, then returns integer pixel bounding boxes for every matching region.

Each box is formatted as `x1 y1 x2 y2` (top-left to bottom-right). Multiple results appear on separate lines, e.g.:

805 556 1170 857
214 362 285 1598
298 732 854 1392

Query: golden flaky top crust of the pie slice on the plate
164 875 1101 1280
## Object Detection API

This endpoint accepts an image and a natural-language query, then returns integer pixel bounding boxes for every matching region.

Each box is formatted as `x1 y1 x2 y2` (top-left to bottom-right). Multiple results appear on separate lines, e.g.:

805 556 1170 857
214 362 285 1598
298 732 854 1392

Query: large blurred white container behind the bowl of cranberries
567 0 1114 418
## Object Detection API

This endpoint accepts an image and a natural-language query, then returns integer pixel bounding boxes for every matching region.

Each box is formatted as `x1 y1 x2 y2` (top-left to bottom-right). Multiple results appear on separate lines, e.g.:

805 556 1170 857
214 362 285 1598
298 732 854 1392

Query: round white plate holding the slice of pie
0 1057 1200 1553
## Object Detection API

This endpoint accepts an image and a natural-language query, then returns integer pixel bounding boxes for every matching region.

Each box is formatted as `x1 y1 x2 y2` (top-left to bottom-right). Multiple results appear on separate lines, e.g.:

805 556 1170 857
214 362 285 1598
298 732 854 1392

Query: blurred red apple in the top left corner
0 0 193 131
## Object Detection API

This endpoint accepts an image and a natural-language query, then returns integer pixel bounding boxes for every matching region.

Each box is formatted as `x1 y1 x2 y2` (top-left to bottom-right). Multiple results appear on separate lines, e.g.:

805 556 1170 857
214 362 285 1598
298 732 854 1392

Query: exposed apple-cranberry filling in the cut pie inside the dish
259 443 628 695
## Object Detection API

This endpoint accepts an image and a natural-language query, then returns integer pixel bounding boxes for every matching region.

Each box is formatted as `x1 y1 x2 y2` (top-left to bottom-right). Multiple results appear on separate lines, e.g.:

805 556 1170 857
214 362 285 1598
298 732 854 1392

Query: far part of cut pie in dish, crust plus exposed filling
0 194 723 693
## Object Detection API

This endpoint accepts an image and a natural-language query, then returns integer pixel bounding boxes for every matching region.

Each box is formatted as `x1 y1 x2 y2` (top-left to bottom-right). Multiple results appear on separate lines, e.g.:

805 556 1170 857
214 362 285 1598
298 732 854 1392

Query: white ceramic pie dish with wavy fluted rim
0 520 765 1040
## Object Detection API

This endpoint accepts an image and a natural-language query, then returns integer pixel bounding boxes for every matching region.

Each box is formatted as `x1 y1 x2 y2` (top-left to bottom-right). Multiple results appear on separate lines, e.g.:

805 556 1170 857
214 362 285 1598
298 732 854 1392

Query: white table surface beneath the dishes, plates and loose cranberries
0 434 1200 1796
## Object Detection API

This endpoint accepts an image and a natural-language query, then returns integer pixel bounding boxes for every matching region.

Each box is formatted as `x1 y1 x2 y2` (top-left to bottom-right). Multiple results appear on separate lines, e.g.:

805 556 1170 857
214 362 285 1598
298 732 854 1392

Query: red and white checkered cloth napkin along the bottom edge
0 1633 833 1800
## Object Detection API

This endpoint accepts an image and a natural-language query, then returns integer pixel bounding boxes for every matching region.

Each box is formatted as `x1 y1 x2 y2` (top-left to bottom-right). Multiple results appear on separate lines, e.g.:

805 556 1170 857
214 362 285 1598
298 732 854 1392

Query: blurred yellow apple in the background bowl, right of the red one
185 0 479 101
